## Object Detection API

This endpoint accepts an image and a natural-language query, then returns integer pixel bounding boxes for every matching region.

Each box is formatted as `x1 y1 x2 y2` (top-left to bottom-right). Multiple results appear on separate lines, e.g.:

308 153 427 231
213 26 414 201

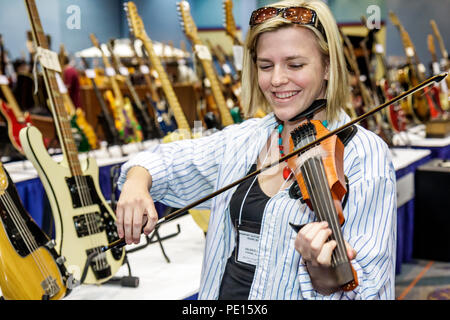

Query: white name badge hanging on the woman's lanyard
235 221 261 266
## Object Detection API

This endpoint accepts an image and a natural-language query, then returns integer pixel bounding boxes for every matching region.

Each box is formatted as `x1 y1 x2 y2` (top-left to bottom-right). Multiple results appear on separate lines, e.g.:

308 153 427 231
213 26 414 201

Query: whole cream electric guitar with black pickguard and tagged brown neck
20 0 125 284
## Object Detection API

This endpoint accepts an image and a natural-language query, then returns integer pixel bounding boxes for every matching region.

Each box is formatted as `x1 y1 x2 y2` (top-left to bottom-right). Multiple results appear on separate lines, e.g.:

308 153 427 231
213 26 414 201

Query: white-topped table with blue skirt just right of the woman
391 148 432 274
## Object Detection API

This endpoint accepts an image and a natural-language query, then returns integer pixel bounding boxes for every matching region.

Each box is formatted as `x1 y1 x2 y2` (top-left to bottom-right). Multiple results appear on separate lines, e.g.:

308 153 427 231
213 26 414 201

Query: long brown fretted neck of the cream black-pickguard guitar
25 0 82 176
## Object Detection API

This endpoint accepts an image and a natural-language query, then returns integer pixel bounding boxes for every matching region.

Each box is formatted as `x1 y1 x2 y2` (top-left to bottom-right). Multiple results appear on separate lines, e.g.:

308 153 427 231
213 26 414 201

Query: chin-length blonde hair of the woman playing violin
241 0 349 121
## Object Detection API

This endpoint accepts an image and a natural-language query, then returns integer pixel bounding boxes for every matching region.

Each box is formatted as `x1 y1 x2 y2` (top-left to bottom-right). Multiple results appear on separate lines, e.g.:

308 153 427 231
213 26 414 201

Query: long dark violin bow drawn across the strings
101 72 448 252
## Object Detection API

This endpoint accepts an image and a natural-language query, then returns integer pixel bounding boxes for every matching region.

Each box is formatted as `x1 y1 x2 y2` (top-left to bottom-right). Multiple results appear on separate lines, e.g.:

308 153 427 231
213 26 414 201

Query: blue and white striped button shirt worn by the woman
119 112 397 299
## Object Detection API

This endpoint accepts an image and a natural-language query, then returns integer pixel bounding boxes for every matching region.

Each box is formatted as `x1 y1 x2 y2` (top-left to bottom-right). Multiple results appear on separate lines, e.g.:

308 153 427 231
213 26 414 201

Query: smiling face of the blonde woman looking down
256 26 328 121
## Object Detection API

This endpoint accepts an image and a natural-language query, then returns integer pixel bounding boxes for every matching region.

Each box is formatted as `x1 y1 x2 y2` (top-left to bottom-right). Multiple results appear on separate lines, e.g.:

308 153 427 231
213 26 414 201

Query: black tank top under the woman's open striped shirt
219 164 270 300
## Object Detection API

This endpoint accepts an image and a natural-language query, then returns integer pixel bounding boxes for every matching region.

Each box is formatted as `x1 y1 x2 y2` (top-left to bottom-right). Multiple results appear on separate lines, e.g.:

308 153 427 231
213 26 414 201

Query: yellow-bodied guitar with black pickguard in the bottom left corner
0 162 73 300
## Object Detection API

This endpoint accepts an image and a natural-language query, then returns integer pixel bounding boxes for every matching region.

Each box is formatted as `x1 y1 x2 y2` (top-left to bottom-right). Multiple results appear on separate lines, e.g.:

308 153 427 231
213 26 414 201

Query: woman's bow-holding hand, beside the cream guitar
116 167 158 244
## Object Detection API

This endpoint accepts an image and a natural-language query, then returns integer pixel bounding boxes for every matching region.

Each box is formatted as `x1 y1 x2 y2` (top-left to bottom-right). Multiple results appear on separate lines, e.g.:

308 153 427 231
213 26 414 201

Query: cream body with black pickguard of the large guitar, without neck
20 126 124 284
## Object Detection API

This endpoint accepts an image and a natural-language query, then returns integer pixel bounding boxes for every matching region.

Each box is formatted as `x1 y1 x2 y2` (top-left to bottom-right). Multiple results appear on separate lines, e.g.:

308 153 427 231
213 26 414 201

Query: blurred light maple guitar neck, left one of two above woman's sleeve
141 39 191 132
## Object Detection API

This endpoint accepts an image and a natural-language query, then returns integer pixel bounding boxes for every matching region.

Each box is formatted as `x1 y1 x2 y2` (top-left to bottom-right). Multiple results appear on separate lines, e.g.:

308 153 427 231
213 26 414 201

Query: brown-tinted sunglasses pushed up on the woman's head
249 7 325 38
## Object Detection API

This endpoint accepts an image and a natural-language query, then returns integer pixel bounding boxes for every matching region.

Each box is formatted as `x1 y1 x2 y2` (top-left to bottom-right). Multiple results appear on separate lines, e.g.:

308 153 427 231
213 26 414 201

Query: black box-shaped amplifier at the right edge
413 159 450 262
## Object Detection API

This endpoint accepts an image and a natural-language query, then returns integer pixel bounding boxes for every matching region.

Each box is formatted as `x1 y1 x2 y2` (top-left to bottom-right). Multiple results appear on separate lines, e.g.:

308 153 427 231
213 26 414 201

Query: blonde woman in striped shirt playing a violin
117 1 396 299
